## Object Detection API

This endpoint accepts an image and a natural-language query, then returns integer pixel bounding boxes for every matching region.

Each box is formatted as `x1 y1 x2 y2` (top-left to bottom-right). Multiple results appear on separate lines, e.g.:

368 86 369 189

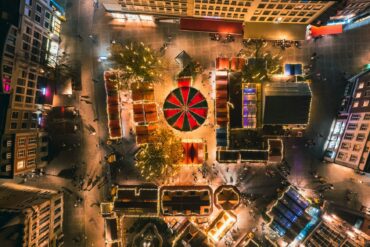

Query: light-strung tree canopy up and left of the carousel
109 41 165 88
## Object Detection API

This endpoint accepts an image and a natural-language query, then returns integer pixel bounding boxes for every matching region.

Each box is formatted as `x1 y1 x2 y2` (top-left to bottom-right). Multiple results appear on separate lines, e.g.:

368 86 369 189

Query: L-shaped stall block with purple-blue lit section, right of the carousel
215 57 283 163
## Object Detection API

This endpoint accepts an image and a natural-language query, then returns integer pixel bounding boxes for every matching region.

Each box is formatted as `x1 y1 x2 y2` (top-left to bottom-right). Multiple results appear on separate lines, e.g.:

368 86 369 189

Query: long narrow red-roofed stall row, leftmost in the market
104 71 122 140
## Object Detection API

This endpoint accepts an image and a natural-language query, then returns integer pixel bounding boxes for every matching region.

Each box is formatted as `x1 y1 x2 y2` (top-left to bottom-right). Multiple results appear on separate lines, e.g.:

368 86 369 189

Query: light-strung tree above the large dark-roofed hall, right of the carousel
241 39 282 82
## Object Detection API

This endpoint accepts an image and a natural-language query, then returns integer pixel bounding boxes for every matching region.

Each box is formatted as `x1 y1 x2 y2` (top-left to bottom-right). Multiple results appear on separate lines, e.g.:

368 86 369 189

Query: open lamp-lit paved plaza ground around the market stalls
2 0 370 247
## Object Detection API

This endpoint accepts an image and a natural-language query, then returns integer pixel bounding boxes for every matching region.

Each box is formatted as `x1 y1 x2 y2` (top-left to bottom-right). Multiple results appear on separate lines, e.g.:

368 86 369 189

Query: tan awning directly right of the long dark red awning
244 22 307 40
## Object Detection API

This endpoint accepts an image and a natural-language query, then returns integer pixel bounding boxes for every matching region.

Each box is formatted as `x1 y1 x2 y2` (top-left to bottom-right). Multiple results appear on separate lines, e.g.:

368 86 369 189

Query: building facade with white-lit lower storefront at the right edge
325 70 370 172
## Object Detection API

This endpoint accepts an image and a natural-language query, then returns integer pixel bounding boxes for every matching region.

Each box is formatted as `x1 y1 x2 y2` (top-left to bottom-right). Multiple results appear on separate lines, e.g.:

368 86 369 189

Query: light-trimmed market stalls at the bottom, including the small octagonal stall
100 184 240 246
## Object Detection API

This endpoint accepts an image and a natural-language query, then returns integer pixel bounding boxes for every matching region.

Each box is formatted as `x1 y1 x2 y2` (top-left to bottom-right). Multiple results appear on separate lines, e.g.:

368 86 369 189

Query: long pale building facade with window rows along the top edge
108 0 334 24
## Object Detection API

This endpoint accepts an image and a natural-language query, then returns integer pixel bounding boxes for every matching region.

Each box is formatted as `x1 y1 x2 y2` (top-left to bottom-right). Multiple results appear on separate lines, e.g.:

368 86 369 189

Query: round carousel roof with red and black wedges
163 87 208 131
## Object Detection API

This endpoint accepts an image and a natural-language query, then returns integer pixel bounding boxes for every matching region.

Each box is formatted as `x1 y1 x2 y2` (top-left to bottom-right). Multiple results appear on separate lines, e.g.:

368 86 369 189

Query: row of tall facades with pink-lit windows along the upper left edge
0 0 62 178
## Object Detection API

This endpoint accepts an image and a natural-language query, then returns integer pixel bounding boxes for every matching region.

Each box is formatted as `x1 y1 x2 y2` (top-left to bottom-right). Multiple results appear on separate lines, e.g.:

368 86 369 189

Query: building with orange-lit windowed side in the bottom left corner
0 183 63 247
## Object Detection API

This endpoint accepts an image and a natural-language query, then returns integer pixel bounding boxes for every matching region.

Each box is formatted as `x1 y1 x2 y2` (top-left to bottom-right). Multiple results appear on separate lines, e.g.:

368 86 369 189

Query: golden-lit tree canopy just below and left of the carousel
136 128 184 181
